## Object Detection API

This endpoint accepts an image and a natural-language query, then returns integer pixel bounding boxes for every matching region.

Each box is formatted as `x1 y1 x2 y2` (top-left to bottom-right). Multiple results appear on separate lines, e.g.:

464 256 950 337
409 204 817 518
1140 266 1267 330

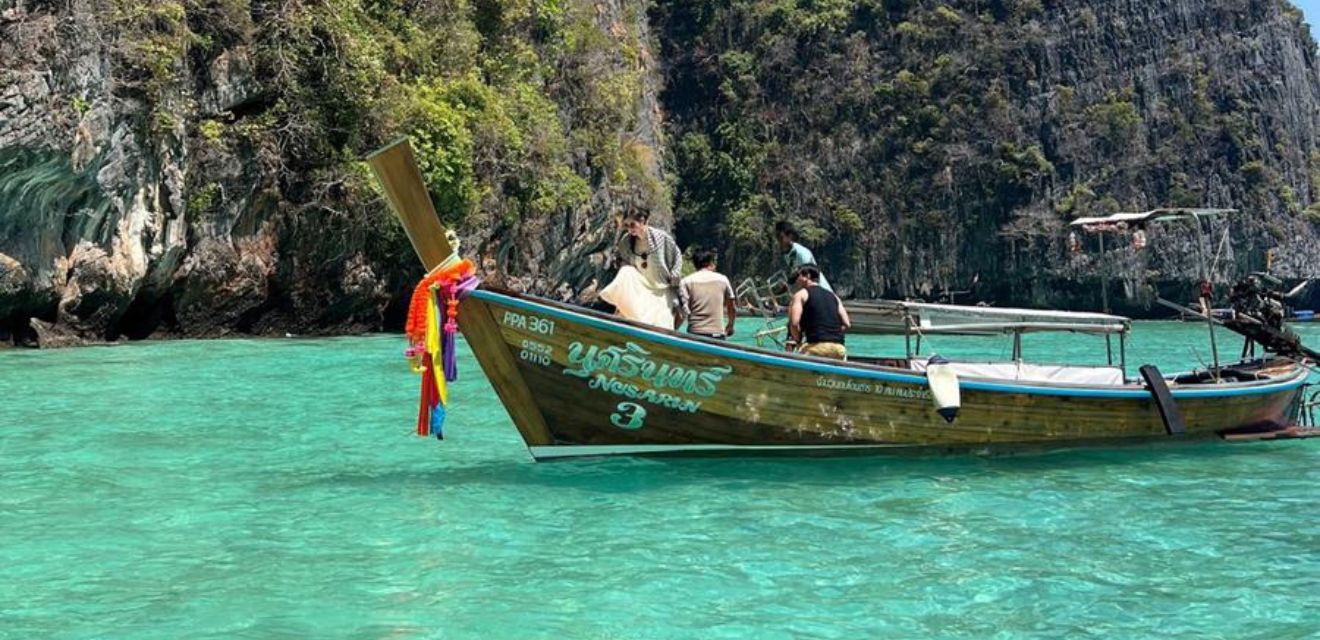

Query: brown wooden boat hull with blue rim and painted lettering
459 290 1307 459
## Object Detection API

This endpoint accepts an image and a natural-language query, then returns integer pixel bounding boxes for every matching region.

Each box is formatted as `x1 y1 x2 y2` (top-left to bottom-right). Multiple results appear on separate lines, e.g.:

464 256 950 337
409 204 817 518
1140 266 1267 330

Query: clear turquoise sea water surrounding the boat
0 321 1320 639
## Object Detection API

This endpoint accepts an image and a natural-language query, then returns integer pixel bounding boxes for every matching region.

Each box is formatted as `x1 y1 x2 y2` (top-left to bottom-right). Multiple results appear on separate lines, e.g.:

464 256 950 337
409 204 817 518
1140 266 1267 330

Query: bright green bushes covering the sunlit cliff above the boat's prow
114 0 664 269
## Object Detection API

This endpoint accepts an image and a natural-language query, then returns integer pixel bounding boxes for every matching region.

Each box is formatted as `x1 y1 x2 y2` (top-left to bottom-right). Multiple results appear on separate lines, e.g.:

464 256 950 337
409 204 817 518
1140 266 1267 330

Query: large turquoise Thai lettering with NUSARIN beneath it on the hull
564 342 733 413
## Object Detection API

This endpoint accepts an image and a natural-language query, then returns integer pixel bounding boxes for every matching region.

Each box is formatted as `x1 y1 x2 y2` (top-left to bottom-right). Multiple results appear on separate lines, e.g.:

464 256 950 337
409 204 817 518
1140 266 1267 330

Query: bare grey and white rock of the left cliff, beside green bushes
0 1 366 344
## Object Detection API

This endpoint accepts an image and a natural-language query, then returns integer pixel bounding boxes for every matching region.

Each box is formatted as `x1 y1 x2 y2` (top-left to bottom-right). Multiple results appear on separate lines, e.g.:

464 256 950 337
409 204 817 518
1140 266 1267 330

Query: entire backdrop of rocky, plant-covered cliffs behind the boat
0 0 1320 344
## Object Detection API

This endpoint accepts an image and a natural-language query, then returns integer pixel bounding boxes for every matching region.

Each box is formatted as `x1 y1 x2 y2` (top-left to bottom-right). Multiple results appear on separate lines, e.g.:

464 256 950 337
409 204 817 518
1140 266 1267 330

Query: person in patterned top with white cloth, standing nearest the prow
601 208 682 330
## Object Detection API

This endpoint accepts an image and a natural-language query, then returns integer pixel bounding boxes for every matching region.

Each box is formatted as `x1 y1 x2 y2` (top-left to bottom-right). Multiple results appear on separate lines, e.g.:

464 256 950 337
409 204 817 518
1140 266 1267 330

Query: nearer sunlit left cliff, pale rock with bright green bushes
0 0 668 346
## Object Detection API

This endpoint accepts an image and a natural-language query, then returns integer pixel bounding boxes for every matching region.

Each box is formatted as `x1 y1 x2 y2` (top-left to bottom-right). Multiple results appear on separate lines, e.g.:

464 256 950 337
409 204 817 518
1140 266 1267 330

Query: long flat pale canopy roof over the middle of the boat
843 300 1131 335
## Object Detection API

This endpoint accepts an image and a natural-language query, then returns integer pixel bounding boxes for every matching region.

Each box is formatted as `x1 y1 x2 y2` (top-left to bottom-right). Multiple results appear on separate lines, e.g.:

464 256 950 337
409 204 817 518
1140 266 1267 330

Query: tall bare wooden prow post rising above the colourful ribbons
367 137 454 271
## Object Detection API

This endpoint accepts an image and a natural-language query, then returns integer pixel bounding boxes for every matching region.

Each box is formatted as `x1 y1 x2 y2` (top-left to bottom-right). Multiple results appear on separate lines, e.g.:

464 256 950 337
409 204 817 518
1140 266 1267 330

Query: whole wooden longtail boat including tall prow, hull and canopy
368 141 1316 461
